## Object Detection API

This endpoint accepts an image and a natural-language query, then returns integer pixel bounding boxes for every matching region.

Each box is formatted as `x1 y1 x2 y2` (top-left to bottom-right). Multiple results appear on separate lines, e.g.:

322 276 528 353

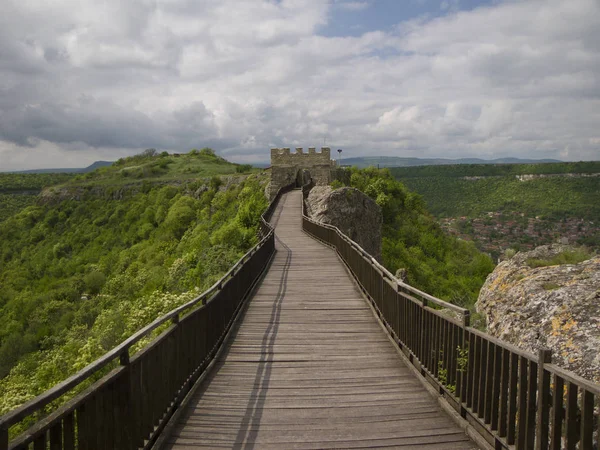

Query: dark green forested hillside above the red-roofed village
390 162 600 220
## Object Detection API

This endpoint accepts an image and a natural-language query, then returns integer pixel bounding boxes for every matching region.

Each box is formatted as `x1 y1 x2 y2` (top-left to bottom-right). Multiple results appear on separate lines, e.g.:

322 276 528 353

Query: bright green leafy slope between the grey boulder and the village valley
334 168 494 307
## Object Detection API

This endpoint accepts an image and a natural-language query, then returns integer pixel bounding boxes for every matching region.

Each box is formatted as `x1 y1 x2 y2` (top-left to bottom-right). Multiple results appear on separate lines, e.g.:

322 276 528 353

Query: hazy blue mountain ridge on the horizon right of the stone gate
342 156 562 168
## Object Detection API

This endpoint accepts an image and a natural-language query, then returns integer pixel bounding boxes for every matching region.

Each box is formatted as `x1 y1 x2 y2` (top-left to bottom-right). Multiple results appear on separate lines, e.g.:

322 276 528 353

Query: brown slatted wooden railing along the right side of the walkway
302 183 600 450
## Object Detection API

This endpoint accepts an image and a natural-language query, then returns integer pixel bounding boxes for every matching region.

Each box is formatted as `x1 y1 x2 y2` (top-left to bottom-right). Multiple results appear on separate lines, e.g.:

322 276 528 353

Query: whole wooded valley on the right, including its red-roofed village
390 161 600 258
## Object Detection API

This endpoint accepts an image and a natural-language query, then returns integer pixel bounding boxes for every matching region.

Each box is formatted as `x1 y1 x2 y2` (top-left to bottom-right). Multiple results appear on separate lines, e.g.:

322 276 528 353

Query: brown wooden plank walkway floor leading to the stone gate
167 191 476 450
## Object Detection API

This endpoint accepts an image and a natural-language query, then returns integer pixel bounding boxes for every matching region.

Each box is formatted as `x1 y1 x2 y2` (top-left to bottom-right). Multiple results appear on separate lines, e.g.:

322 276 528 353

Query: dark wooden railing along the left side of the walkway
0 181 294 450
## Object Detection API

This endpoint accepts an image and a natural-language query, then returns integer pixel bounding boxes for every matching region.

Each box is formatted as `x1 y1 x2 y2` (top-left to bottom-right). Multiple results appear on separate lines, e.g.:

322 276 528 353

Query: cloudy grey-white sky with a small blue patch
0 0 600 170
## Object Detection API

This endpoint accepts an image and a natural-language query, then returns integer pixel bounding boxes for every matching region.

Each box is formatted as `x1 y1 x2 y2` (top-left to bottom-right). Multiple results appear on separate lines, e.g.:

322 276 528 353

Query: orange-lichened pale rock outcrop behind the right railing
475 245 600 383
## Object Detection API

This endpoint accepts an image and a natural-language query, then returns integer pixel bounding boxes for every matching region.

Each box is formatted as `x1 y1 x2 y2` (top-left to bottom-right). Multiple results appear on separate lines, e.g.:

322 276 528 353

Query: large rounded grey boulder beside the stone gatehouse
306 186 383 261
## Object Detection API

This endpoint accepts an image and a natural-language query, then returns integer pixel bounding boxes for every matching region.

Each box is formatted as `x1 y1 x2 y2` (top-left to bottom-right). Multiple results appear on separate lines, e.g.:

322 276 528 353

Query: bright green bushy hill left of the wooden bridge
0 149 268 414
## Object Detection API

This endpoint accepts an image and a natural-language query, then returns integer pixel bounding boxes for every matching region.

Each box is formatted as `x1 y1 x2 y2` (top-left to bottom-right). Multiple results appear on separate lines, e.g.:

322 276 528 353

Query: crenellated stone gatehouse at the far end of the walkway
270 147 336 200
